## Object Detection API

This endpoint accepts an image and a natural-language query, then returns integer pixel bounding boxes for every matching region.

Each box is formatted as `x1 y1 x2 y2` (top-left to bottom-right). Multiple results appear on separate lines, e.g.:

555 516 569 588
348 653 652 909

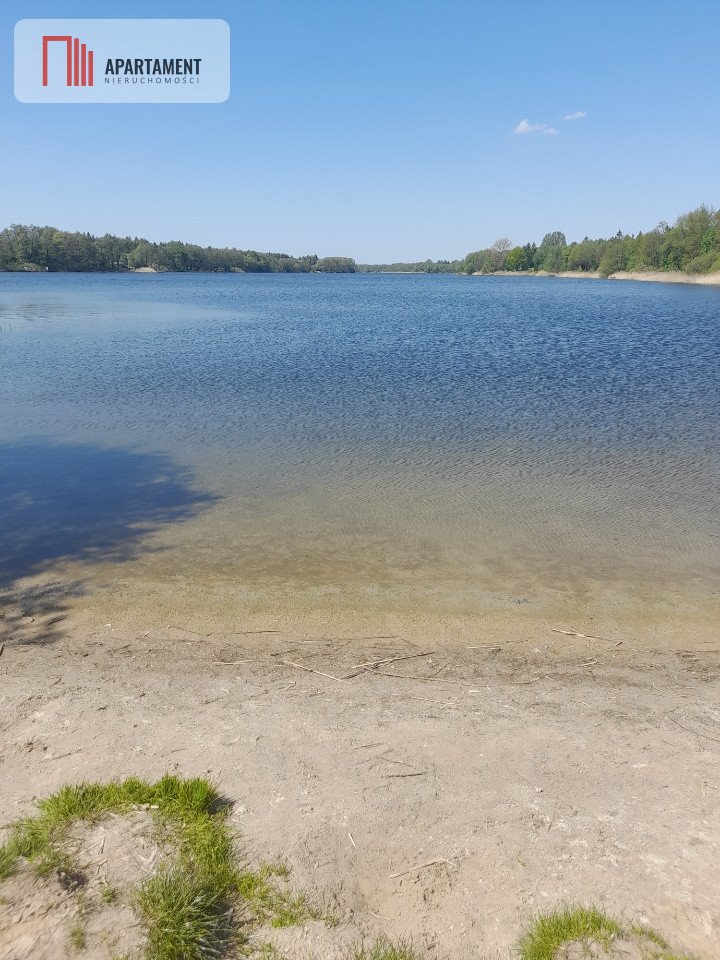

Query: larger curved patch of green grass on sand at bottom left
0 776 317 960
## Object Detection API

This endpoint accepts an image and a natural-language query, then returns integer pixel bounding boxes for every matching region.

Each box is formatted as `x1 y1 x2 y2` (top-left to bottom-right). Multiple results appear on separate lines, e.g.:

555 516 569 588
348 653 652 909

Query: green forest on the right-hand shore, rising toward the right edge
357 206 720 277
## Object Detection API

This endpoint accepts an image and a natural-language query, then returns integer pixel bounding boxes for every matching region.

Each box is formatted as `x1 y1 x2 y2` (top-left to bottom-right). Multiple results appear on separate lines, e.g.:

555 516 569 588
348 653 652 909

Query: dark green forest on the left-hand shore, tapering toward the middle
0 230 356 273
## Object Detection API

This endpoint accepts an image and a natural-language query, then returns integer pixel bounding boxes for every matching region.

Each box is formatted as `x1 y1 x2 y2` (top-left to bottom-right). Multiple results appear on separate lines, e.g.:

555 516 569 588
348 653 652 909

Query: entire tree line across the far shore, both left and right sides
0 206 720 277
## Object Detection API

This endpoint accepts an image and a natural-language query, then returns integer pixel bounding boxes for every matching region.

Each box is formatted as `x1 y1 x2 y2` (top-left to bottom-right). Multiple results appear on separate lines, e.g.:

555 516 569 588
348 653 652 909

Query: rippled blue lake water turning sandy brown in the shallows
0 274 720 636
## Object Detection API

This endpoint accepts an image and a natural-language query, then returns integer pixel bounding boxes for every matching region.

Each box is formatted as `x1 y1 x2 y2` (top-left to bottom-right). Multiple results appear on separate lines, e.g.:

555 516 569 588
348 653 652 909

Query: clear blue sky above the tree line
0 0 720 262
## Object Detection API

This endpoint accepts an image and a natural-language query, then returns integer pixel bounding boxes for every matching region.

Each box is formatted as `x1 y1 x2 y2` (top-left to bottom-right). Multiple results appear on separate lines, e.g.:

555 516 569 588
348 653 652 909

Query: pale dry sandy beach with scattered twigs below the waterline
0 616 720 960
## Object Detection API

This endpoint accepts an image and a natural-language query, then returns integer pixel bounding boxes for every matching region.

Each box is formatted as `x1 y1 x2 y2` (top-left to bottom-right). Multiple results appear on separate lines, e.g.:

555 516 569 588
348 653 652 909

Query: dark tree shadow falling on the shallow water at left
0 440 218 643
